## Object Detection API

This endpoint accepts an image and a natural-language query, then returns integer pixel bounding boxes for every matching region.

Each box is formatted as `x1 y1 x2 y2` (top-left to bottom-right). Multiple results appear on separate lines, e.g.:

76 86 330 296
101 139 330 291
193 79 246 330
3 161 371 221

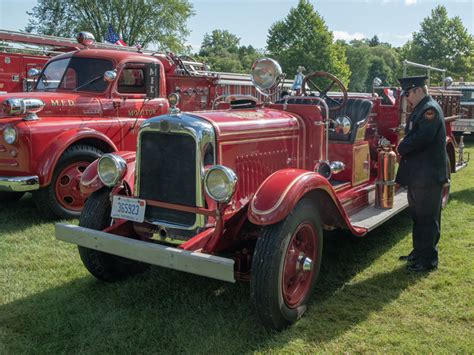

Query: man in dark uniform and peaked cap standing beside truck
396 76 448 272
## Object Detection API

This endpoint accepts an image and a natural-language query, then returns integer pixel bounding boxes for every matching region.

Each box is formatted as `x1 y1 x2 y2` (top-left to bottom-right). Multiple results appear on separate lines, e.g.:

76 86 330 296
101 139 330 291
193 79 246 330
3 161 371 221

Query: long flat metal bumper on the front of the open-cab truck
55 223 235 282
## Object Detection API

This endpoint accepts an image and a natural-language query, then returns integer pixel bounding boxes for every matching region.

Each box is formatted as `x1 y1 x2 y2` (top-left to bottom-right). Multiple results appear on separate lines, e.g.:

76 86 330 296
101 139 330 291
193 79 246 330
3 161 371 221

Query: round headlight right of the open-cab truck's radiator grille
204 165 237 203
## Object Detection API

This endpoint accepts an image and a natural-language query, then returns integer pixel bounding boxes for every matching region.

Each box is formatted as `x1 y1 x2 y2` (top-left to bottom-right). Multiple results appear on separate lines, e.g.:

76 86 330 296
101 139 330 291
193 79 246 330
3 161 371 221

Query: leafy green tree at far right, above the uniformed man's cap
403 5 474 79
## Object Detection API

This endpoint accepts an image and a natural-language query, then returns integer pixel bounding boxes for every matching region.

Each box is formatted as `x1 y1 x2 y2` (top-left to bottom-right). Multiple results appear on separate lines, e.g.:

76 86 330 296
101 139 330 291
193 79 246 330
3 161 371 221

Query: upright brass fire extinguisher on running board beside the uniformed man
375 138 397 209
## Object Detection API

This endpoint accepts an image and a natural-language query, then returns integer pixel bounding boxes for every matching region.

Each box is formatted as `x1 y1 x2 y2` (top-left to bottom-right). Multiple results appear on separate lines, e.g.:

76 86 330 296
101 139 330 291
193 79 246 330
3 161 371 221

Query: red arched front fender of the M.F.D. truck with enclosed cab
37 129 118 186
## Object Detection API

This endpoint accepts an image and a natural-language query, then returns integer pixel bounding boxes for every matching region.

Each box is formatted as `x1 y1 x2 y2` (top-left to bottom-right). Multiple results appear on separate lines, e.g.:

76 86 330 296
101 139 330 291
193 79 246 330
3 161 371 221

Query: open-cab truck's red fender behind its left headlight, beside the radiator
79 151 136 196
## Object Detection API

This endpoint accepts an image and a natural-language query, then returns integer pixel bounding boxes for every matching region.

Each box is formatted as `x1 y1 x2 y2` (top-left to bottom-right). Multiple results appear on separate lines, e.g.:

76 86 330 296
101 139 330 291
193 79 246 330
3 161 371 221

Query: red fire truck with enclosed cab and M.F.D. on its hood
0 33 270 218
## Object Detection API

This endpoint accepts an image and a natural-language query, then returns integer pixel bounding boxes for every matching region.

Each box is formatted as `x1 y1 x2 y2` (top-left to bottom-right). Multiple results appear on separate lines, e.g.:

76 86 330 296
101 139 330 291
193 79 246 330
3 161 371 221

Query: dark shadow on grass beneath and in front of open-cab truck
0 210 422 353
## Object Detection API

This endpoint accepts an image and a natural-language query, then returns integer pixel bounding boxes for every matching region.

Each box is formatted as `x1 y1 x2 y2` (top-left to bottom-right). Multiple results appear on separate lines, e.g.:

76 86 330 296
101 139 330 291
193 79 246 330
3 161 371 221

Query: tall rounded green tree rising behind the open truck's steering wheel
267 0 350 83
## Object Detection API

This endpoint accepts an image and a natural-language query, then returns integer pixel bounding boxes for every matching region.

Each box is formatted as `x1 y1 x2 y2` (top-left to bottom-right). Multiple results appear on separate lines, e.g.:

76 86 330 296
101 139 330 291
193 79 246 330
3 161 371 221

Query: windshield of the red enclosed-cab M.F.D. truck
36 57 113 92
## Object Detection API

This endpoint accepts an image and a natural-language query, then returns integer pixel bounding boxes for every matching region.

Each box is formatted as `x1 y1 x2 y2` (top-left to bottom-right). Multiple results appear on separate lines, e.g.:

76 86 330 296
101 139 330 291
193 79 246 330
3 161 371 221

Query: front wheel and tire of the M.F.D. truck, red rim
33 145 102 219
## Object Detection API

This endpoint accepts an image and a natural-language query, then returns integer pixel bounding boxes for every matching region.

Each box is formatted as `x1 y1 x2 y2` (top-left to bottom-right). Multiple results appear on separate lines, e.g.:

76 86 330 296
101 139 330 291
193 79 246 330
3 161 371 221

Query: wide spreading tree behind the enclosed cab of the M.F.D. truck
25 0 194 51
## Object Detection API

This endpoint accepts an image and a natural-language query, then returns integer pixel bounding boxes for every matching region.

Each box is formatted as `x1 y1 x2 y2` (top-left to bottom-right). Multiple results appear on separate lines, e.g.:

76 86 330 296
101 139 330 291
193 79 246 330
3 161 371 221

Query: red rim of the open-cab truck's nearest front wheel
282 222 317 308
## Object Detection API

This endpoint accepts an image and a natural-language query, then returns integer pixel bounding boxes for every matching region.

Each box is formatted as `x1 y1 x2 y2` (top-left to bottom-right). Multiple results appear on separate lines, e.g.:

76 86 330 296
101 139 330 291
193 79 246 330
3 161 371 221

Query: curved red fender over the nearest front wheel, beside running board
247 169 367 236
